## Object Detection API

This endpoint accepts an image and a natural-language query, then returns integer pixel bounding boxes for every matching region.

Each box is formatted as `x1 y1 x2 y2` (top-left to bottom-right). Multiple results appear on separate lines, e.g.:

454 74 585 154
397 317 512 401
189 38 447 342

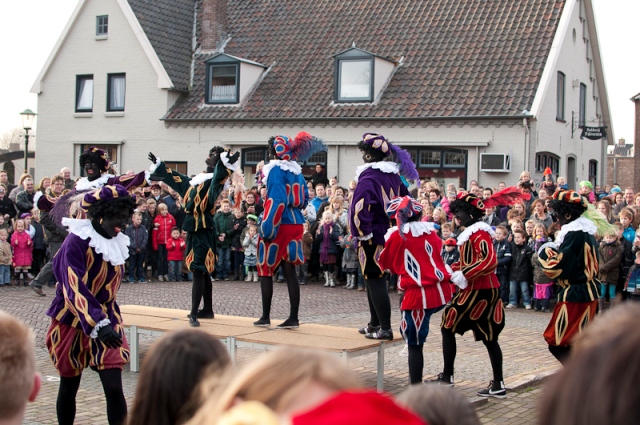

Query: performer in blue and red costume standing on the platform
253 132 326 329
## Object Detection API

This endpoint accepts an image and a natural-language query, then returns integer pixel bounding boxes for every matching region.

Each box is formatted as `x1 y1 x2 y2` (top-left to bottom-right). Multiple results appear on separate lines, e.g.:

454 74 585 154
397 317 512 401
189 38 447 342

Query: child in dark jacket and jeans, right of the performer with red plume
507 229 533 310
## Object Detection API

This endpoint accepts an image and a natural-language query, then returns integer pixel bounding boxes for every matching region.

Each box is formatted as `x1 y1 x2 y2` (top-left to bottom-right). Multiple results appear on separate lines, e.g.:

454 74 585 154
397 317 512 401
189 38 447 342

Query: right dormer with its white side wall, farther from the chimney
334 47 395 103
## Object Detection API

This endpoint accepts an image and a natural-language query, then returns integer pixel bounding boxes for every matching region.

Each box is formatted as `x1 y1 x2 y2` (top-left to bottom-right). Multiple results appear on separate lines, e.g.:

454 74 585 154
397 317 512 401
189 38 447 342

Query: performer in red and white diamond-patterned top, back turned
379 196 454 384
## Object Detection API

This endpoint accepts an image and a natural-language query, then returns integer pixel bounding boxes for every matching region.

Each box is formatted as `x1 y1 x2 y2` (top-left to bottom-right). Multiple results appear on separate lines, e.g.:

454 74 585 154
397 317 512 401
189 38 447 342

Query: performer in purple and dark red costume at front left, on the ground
46 185 135 425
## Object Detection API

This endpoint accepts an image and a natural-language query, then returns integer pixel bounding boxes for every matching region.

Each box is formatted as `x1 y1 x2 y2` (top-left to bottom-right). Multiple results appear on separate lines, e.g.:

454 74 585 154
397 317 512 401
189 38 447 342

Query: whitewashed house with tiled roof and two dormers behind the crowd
32 0 615 190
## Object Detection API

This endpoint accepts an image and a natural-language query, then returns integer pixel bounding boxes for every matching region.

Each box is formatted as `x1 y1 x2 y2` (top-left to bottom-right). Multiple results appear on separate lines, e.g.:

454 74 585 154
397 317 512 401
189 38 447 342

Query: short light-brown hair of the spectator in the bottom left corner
0 310 36 420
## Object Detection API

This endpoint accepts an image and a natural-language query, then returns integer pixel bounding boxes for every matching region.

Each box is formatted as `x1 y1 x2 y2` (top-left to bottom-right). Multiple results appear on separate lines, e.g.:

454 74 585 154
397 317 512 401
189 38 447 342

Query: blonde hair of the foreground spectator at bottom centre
187 348 361 425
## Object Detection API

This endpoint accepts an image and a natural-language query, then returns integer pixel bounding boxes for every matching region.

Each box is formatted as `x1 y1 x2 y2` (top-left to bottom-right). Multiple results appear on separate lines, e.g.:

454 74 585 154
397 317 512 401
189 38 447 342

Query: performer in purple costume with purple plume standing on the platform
349 133 419 339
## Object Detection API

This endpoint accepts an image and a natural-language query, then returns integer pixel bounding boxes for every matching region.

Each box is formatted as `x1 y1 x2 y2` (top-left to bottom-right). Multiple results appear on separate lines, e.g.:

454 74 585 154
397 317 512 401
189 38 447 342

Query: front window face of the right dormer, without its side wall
334 48 374 102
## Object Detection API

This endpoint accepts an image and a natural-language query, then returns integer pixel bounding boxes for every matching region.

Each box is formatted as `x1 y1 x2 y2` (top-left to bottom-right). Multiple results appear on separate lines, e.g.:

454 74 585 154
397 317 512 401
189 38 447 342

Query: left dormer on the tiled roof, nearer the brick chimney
205 54 266 105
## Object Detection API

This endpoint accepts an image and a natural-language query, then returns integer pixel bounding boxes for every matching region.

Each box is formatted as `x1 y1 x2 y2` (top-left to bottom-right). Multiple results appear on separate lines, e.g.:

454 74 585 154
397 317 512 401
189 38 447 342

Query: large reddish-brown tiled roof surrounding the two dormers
165 0 564 120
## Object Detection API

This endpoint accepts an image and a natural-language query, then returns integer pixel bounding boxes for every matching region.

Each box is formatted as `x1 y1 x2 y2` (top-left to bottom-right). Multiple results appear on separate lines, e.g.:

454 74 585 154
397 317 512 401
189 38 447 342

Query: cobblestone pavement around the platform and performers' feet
0 276 558 424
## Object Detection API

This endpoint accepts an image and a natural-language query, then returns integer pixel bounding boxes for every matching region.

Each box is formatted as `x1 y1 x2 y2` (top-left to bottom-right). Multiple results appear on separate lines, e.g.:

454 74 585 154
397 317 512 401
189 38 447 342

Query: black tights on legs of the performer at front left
56 369 127 425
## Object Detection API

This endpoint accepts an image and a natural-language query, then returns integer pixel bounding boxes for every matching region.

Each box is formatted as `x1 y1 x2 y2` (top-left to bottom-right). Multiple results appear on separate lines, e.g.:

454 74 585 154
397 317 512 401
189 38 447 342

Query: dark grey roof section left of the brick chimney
128 0 195 90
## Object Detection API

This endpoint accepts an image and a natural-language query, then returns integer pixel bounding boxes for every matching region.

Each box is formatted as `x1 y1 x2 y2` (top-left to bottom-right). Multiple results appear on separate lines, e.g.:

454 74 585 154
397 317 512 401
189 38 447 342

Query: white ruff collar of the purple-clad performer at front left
62 217 129 266
